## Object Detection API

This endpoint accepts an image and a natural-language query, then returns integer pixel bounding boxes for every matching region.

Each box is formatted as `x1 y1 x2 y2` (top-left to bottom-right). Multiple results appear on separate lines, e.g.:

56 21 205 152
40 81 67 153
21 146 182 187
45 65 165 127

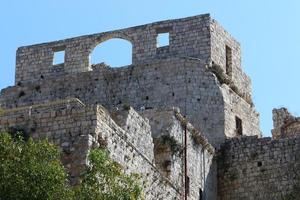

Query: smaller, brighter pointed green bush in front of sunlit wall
76 149 141 200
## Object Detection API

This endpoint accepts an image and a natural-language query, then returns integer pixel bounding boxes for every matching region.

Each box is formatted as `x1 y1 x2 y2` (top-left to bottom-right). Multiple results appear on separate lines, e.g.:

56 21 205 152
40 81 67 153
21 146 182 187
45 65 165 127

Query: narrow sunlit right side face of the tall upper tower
211 20 261 137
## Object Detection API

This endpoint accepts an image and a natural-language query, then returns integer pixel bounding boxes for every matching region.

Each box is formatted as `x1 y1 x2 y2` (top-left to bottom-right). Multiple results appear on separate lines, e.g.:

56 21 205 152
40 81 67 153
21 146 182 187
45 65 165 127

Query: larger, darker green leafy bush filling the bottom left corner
0 133 72 200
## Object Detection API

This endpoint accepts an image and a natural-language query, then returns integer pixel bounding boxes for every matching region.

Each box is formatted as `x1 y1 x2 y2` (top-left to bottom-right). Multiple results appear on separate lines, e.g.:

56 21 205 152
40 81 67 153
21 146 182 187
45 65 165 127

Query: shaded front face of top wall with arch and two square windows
15 15 210 85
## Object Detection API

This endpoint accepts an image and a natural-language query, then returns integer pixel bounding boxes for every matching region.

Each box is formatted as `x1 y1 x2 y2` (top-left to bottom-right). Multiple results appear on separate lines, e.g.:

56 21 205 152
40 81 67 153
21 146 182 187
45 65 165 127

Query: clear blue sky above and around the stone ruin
0 0 300 136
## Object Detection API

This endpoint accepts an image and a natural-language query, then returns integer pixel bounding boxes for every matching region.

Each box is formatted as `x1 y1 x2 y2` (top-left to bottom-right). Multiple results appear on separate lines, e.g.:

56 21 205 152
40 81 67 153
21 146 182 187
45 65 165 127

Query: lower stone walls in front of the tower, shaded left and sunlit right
0 99 220 199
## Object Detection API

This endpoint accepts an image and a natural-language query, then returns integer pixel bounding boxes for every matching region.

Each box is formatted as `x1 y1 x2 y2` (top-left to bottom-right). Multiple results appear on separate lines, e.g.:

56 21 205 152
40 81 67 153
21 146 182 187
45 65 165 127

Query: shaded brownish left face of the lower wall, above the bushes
0 100 97 183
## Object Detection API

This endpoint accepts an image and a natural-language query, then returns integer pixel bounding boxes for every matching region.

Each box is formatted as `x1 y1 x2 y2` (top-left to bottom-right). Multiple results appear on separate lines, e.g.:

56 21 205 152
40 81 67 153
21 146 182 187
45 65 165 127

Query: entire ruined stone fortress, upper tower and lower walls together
0 14 300 200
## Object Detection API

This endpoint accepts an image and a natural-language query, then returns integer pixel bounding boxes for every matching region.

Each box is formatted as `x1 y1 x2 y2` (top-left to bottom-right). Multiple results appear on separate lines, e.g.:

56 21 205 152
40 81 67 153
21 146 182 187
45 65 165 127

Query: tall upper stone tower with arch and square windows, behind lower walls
0 14 261 146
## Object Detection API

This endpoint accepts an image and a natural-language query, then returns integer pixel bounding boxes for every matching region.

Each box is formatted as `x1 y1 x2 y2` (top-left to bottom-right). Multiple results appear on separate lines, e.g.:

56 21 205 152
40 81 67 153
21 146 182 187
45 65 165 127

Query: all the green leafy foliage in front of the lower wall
0 133 141 200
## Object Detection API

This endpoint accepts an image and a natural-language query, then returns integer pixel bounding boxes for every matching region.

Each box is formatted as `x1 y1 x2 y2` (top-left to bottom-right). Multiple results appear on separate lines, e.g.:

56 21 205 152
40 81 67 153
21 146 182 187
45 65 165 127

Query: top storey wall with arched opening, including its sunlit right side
15 14 251 100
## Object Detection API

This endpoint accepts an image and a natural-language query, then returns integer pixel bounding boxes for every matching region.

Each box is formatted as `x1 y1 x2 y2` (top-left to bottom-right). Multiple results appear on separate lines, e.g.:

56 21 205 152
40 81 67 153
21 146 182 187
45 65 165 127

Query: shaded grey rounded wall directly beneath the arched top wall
0 58 225 144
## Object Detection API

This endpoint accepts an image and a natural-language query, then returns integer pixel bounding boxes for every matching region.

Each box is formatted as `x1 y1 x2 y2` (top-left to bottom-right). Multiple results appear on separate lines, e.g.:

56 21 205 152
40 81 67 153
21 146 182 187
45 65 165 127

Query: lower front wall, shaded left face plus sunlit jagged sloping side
0 99 180 200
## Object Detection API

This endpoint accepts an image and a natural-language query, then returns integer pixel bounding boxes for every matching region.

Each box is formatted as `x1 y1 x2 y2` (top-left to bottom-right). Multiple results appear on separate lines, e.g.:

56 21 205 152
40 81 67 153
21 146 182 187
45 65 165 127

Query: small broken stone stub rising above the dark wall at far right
272 108 300 138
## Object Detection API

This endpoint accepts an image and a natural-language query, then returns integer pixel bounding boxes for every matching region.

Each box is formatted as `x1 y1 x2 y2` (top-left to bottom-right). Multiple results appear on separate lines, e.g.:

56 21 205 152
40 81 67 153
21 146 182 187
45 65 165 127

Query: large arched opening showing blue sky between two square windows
90 38 132 67
